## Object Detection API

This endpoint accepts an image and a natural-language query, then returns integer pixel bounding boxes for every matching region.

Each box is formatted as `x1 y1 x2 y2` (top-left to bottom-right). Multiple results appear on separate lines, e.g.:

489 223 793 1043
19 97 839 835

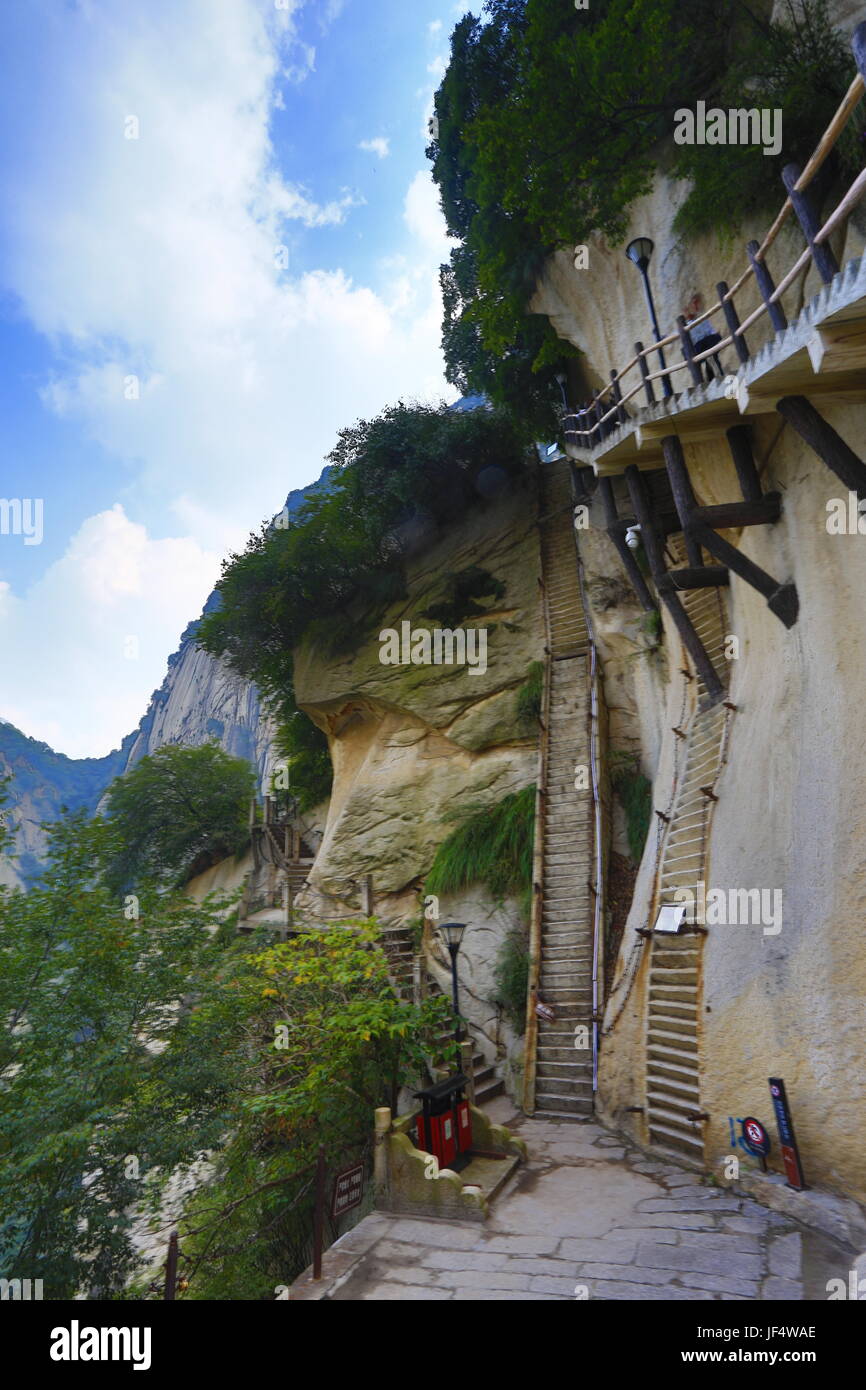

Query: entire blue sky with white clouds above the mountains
0 0 468 756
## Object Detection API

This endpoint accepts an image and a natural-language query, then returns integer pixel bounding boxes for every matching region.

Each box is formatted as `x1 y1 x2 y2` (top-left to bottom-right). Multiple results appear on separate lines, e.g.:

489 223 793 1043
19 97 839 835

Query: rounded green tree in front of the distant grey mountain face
108 744 256 890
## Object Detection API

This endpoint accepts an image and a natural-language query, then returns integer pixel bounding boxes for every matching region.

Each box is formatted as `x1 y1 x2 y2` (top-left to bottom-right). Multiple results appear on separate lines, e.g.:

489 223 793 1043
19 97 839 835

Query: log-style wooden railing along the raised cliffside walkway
563 21 866 449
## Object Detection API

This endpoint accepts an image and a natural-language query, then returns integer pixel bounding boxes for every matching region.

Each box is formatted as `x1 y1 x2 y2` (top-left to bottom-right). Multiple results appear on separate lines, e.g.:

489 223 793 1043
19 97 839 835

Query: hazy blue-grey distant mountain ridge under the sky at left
0 466 334 887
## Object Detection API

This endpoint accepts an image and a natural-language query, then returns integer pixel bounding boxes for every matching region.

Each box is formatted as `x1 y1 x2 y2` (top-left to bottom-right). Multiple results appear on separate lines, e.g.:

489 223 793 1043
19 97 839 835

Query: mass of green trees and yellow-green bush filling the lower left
0 813 453 1300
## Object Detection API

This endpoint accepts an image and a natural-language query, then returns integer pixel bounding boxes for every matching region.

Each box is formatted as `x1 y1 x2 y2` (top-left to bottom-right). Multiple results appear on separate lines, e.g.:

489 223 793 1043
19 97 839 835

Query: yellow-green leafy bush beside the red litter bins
155 922 453 1300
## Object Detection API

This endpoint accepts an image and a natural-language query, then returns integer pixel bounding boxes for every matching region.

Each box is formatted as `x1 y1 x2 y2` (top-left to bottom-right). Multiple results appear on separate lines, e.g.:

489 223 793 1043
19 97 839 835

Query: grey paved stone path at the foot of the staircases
291 1116 851 1301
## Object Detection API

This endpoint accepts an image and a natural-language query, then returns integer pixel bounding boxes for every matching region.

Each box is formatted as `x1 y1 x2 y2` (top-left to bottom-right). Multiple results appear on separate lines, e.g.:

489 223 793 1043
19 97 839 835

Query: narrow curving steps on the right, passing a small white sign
646 558 728 1162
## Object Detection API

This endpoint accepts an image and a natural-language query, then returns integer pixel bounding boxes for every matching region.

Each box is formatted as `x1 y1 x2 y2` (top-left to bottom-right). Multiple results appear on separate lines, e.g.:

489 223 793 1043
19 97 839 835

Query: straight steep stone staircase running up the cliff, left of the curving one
535 463 594 1119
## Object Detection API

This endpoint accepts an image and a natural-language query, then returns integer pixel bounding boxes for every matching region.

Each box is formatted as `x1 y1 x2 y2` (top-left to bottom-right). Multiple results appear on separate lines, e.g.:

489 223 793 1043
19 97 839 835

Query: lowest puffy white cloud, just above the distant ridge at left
0 505 218 758
